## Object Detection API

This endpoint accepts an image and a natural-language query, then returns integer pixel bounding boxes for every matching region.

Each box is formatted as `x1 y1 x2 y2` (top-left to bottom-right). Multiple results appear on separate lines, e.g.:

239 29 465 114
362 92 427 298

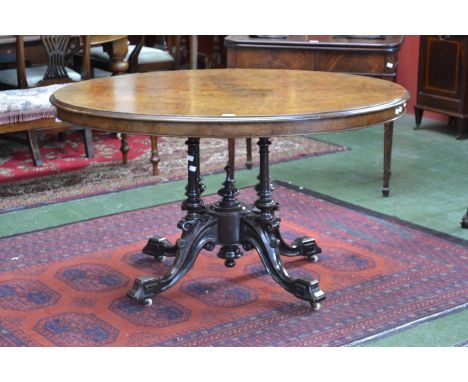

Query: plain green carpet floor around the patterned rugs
0 115 468 346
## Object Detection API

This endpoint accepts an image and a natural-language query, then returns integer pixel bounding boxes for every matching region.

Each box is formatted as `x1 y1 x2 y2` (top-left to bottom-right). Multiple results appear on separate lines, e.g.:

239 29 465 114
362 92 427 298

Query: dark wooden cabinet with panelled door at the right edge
414 36 468 139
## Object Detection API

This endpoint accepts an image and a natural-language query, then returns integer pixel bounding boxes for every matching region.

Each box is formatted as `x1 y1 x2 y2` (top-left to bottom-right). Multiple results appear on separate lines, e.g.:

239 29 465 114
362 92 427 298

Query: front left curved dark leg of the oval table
127 215 217 305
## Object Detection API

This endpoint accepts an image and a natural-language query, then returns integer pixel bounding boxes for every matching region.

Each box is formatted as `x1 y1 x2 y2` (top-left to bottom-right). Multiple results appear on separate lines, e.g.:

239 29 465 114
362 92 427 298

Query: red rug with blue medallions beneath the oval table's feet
0 185 468 346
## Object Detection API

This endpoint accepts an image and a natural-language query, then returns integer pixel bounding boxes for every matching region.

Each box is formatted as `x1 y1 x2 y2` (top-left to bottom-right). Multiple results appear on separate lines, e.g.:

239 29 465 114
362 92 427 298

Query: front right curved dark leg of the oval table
243 218 325 310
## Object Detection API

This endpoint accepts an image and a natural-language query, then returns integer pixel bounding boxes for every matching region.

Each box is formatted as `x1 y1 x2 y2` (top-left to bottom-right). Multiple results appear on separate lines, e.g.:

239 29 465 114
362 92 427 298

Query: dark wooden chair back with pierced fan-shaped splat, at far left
16 35 91 89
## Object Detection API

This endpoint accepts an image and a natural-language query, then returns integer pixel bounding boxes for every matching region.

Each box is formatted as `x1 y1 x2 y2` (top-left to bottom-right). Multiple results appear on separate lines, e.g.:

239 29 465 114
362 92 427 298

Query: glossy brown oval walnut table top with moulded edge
51 69 409 138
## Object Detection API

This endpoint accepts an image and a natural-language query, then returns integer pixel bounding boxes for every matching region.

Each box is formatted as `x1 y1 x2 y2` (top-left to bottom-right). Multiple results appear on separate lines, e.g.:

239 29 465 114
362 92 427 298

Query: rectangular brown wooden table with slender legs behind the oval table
224 35 403 196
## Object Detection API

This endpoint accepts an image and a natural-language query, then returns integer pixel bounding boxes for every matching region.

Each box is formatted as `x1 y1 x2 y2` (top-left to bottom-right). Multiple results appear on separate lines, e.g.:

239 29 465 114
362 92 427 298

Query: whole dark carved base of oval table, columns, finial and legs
128 138 325 310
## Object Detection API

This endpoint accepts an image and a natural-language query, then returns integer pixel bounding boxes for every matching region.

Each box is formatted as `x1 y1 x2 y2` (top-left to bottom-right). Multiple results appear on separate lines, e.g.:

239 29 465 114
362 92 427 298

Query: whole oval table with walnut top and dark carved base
51 69 409 309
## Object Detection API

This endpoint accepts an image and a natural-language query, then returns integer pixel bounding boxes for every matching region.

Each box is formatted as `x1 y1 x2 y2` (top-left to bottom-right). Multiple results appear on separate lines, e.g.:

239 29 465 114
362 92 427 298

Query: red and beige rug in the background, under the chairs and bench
0 132 347 211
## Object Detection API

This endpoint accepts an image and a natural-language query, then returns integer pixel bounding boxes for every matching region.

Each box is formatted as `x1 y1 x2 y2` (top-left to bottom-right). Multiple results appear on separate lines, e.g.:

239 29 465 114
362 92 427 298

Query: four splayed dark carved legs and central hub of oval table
128 205 325 310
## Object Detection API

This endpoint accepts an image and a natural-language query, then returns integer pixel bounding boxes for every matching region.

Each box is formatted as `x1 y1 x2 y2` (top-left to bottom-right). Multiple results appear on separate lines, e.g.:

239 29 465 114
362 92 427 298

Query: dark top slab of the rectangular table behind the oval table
224 35 404 50
